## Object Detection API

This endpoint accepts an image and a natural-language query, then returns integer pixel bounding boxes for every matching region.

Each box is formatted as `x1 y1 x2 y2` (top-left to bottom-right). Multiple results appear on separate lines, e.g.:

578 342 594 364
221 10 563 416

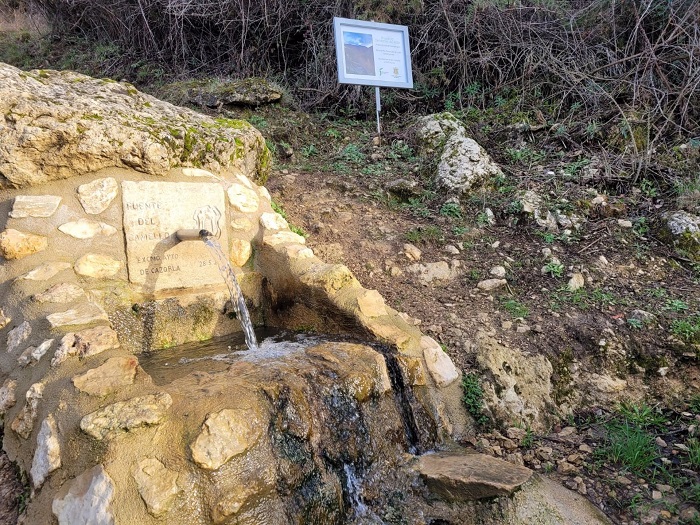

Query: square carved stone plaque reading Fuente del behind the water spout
122 181 228 291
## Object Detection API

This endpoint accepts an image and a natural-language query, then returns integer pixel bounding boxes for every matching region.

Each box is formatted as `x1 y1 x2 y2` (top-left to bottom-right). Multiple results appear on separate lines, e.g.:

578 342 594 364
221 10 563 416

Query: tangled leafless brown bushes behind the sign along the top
31 0 700 145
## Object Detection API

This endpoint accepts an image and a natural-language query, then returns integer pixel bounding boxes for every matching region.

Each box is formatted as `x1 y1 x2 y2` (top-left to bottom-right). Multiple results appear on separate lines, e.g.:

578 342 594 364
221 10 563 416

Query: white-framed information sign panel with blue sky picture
333 18 413 88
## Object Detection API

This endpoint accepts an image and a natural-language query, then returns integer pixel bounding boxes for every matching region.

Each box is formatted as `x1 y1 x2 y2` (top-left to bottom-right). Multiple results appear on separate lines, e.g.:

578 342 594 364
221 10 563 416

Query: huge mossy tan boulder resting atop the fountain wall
0 64 270 186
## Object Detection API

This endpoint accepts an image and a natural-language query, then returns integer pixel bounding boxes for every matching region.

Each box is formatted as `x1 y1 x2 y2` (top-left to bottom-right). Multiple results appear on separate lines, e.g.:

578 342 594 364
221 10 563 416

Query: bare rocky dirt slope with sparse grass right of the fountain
252 100 700 524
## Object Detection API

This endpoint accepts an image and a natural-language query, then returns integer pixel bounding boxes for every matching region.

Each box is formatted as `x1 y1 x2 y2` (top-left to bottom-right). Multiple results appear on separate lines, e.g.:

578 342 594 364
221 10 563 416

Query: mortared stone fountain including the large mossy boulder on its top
0 64 604 525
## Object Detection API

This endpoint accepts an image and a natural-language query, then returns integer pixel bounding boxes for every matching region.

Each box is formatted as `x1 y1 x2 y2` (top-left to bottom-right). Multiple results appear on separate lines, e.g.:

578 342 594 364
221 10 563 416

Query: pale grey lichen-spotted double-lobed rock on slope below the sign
418 112 502 194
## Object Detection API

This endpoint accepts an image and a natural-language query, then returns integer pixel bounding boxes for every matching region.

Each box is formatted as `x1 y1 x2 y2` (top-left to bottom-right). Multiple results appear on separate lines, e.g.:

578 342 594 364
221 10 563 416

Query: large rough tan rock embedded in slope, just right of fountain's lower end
476 332 557 432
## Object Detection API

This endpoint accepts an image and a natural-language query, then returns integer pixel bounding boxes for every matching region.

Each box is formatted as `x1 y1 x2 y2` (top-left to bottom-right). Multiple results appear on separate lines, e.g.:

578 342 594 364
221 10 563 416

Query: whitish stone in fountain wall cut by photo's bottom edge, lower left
51 465 114 525
